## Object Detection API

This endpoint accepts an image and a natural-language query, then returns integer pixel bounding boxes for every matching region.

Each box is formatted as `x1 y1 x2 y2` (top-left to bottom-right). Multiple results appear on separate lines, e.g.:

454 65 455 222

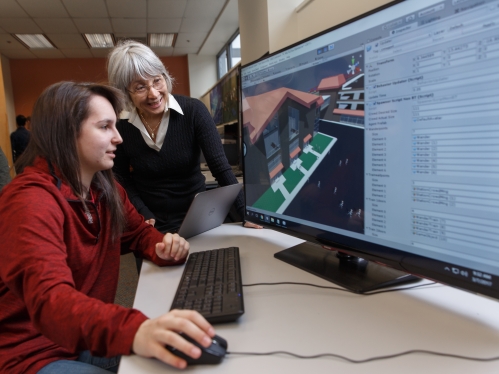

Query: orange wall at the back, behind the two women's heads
10 56 190 116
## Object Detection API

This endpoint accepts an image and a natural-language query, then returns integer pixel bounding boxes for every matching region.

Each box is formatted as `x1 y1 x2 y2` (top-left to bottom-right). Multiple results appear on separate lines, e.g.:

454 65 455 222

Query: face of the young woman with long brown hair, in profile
76 95 123 187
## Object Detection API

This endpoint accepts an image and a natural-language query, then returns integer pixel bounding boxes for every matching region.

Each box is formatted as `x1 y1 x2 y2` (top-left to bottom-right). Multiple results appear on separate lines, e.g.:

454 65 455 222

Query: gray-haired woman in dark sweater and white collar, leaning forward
107 40 259 232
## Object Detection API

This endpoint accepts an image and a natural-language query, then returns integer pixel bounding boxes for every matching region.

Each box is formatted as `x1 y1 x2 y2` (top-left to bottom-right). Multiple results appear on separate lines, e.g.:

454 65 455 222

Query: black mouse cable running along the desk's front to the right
226 349 499 364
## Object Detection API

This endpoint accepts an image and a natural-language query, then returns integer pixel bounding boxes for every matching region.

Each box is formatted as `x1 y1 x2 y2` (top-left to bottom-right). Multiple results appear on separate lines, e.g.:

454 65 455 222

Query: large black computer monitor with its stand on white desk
241 0 499 298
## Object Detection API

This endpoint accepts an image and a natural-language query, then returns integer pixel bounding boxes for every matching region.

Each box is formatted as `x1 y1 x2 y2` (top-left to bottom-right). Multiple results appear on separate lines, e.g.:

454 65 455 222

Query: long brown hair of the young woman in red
16 82 126 239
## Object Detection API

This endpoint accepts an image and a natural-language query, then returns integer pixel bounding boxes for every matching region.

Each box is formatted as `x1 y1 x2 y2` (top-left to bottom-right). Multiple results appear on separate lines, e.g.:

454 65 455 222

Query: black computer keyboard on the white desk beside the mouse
171 247 244 323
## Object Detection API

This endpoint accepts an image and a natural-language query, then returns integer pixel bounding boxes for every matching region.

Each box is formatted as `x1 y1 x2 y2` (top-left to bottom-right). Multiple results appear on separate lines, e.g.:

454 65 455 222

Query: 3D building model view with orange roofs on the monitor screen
242 53 364 232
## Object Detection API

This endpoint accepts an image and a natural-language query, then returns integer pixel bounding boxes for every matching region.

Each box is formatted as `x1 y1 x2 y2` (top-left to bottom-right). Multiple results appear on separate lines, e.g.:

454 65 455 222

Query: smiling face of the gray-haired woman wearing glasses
128 75 168 117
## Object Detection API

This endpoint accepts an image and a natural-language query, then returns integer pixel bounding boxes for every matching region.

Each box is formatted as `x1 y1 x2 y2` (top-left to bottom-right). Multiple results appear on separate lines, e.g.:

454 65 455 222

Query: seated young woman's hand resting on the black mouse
132 310 215 369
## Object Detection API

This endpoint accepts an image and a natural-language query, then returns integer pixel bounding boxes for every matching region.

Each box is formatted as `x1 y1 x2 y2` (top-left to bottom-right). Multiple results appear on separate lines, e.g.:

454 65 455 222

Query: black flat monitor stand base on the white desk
274 242 420 293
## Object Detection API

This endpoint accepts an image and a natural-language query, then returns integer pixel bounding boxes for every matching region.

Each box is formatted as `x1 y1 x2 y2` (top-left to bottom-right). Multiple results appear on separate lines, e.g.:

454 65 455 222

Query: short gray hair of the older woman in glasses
107 40 174 107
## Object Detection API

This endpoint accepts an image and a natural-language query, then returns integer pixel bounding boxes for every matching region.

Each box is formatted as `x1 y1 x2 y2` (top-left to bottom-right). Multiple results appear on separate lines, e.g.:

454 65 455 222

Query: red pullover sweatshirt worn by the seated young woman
0 158 185 373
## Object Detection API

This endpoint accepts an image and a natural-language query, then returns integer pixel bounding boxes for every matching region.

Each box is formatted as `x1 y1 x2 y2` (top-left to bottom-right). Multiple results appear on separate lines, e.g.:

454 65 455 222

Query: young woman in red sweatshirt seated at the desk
0 82 215 374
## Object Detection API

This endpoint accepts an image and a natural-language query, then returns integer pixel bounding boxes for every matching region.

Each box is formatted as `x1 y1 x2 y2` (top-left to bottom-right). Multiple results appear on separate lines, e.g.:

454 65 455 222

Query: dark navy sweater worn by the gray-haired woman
113 95 244 232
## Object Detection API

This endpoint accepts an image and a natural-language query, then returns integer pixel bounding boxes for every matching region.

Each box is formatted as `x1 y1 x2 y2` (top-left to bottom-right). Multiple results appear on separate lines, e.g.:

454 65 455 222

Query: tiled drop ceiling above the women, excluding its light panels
0 0 239 59
